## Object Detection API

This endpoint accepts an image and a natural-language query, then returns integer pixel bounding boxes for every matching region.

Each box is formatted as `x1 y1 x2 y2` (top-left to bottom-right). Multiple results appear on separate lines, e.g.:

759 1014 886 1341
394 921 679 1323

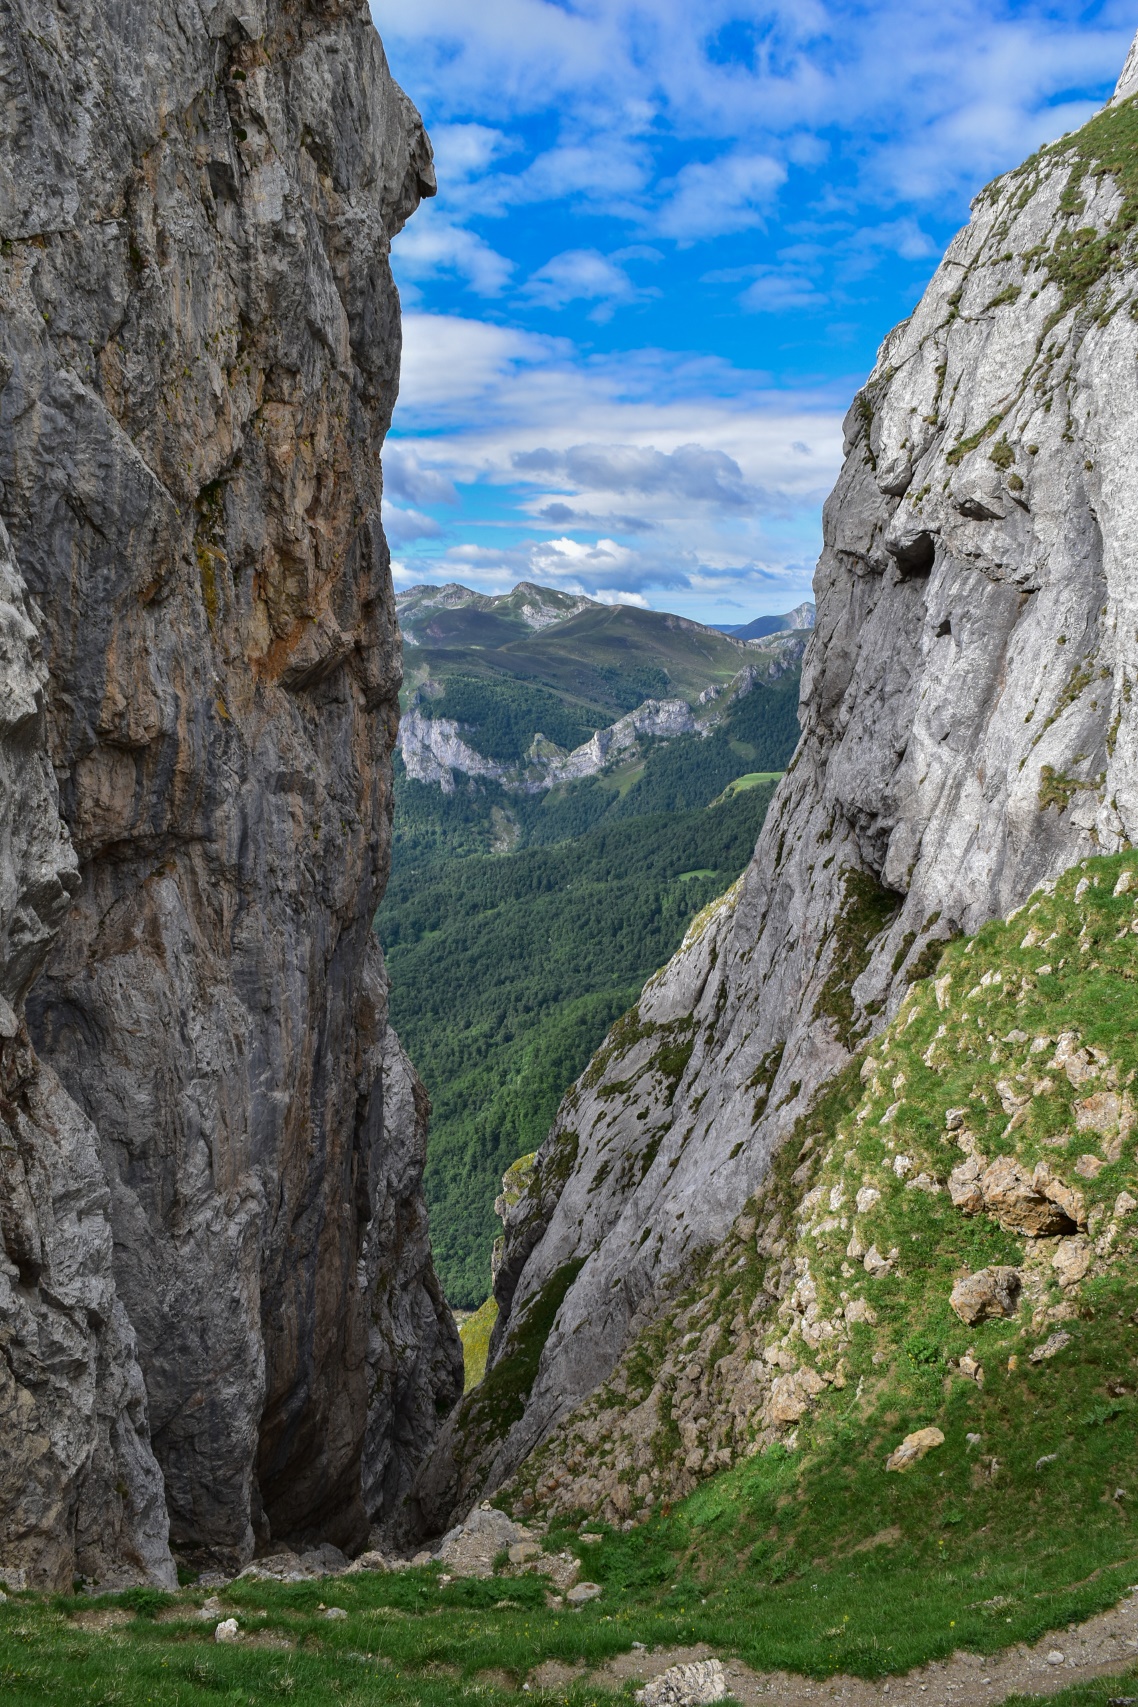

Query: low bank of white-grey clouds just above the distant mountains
386 314 848 616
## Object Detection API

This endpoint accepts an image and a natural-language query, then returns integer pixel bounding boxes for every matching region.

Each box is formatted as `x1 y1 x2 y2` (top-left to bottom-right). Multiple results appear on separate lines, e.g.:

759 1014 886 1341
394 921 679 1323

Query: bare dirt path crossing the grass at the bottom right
529 1591 1138 1707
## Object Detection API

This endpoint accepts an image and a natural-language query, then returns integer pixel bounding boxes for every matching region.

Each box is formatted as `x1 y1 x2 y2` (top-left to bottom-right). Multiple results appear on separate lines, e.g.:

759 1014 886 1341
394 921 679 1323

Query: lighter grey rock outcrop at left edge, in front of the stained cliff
0 522 177 1593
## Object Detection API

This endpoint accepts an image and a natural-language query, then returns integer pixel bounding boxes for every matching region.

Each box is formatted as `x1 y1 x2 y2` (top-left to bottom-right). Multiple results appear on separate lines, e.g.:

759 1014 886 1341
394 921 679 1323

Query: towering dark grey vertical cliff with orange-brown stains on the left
0 0 461 1565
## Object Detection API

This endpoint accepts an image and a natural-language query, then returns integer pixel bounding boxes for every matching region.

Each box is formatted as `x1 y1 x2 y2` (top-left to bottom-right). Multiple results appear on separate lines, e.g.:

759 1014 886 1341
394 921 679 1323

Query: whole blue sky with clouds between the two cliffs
372 0 1138 623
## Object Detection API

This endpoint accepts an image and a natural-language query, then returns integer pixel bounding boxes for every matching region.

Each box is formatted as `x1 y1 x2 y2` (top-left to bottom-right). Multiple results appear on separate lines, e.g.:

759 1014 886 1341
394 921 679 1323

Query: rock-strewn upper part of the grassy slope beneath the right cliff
498 855 1138 1529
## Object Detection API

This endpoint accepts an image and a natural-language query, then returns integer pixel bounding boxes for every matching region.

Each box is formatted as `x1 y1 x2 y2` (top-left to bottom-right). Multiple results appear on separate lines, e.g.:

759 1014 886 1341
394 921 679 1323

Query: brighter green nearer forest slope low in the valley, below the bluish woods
379 780 775 1309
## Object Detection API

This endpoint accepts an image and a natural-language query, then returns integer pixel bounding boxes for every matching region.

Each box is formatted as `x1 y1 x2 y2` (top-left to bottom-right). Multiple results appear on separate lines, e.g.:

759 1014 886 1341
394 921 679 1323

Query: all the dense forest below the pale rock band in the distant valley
377 673 798 1309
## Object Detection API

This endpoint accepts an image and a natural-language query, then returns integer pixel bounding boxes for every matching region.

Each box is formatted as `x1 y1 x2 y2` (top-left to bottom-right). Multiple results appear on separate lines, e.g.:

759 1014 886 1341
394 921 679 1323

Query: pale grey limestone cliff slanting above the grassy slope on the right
418 55 1138 1526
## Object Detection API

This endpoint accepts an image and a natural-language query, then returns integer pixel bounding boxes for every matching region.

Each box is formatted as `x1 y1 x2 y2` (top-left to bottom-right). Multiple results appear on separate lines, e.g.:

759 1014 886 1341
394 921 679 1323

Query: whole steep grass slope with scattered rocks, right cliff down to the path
494 855 1138 1675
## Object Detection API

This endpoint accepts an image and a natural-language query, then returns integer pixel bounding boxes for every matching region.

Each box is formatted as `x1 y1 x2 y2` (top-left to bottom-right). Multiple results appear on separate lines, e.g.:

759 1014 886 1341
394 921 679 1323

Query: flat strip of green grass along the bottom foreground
8 1515 1135 1707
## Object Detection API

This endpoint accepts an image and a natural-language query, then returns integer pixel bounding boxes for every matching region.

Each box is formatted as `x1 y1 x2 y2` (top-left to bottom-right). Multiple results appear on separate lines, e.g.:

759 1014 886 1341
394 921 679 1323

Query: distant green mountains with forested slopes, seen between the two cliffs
377 587 798 1308
